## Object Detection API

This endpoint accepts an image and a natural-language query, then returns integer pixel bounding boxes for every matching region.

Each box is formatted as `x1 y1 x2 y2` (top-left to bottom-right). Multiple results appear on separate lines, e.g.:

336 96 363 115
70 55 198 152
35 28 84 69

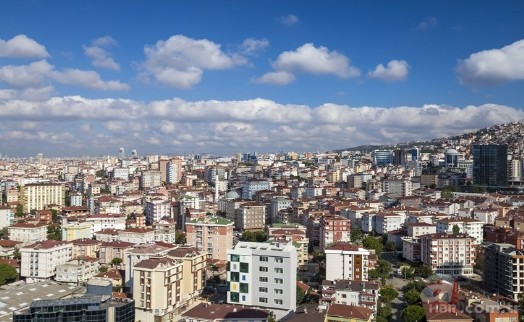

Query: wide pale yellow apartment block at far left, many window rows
20 183 65 212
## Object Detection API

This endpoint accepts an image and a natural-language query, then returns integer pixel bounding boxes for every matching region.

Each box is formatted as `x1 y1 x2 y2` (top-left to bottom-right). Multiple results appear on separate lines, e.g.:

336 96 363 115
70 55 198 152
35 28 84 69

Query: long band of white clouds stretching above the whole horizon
0 91 524 155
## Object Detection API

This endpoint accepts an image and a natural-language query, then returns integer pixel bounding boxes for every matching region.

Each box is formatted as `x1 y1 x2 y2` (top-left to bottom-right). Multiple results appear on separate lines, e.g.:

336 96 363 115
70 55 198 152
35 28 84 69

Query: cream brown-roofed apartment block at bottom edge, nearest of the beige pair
133 257 183 321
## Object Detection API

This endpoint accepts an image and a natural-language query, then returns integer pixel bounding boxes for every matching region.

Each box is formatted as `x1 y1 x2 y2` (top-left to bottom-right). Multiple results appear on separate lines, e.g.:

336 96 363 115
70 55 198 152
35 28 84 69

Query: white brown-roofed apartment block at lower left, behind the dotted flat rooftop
20 240 73 283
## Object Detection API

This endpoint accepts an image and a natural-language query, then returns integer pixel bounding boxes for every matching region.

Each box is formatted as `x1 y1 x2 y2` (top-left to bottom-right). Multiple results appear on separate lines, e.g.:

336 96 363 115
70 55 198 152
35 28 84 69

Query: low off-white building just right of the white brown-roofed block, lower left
55 259 100 283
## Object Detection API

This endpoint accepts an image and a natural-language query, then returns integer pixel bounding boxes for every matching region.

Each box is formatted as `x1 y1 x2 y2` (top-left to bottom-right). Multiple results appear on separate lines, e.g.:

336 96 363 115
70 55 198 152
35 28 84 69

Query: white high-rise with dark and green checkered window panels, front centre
227 242 297 319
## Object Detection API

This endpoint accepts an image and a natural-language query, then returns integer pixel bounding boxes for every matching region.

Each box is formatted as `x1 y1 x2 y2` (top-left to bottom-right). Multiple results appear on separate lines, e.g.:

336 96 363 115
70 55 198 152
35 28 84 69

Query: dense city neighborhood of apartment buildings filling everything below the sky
0 123 524 322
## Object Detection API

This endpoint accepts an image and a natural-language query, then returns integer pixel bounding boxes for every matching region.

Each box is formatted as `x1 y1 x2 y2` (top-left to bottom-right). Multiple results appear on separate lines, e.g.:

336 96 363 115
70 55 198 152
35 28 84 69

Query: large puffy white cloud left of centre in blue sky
141 35 246 88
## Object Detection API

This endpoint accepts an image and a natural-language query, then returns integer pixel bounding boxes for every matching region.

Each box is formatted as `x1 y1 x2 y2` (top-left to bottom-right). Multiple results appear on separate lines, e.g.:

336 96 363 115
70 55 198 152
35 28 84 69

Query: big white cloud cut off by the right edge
456 39 524 85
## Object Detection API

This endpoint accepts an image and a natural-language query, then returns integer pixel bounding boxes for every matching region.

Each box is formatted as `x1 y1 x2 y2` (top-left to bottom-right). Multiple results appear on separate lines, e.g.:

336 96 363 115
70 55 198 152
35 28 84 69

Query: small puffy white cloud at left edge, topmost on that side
0 35 49 58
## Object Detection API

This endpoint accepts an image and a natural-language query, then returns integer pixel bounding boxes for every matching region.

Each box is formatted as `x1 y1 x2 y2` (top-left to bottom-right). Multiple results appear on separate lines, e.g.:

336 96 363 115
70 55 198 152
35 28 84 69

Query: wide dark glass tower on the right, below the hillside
472 144 508 187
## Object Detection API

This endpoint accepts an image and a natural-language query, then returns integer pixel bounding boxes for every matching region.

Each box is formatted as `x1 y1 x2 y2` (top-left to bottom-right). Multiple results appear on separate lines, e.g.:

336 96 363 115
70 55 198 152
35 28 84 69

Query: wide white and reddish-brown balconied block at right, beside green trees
420 233 477 275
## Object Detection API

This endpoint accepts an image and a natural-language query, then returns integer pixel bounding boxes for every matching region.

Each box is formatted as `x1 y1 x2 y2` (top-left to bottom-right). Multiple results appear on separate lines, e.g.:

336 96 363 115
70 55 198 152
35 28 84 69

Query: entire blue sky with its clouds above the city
0 1 524 156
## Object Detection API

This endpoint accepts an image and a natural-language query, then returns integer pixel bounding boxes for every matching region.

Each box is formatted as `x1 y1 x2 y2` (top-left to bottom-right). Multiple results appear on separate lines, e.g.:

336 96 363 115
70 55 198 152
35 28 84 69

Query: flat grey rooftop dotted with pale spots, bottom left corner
0 281 85 322
